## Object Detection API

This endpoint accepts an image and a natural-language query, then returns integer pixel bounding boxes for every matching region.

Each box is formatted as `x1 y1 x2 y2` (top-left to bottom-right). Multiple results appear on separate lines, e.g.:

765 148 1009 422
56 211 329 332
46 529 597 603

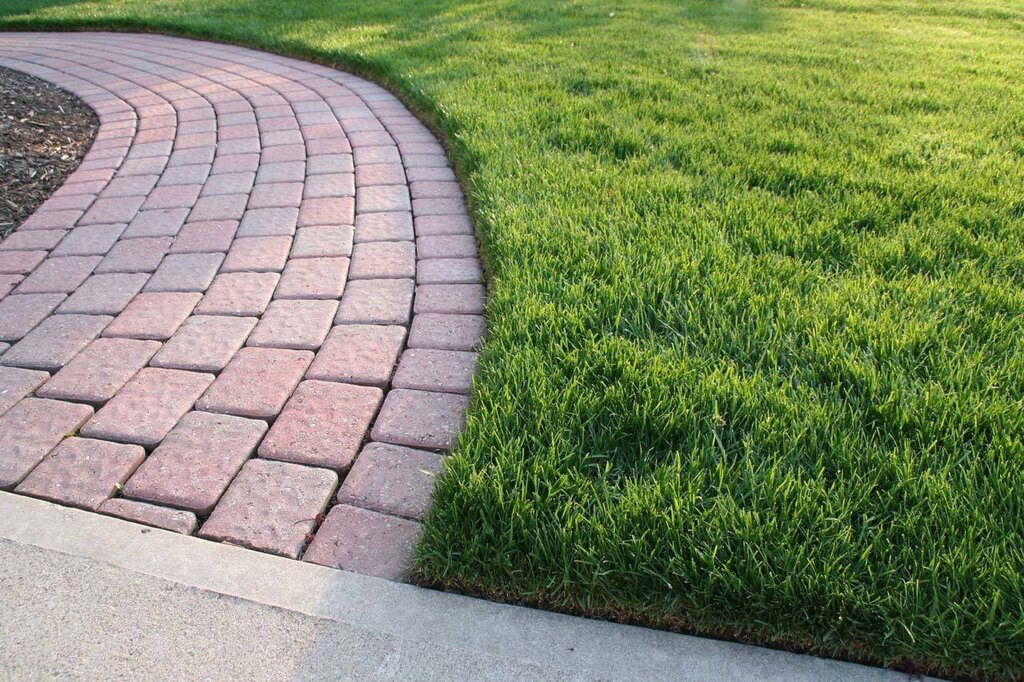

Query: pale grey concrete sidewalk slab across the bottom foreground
0 493 929 681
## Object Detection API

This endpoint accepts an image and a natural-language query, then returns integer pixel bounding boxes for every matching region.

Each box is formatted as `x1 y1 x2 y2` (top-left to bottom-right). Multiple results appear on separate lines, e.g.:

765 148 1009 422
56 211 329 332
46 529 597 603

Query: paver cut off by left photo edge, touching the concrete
0 398 92 491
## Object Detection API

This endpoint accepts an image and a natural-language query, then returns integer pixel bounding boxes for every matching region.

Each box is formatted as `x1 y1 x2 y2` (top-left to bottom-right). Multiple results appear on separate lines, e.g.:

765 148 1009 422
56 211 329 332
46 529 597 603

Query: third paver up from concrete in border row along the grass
371 388 469 451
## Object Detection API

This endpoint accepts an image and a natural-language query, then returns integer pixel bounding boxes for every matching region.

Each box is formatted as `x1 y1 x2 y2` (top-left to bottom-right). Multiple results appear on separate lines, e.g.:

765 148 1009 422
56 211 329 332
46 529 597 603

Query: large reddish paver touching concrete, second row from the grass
199 460 338 559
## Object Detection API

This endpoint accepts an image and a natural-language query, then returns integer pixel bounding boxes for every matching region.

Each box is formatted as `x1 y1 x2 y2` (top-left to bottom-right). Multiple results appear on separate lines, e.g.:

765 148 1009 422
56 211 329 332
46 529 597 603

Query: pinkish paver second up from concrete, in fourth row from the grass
82 368 213 446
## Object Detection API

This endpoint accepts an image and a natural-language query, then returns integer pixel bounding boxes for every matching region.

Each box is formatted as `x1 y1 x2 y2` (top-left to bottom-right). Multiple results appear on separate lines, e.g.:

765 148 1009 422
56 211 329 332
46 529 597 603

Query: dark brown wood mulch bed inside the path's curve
0 67 99 239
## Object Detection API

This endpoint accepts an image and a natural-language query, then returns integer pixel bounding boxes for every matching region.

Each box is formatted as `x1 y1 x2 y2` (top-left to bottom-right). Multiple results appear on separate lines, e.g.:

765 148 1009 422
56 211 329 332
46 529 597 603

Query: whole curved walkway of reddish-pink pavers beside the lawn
0 34 484 580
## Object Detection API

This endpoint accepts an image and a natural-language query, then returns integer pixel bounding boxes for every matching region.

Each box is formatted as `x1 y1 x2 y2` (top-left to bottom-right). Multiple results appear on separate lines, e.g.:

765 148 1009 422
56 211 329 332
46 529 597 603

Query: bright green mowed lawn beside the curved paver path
0 0 1024 677
